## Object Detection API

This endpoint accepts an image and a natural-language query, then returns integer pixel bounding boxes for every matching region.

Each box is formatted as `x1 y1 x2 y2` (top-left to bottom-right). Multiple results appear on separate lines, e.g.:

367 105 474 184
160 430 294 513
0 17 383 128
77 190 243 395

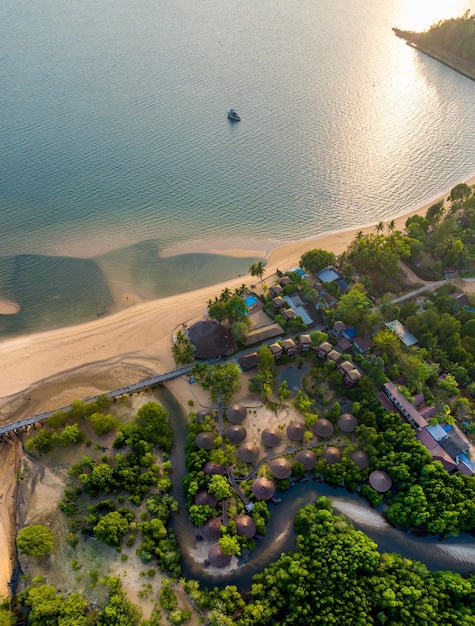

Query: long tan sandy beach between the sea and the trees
0 176 475 414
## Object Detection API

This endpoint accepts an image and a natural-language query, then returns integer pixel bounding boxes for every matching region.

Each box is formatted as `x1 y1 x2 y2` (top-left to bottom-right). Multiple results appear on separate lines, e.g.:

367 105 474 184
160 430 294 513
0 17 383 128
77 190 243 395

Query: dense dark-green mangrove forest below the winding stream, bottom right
205 498 475 626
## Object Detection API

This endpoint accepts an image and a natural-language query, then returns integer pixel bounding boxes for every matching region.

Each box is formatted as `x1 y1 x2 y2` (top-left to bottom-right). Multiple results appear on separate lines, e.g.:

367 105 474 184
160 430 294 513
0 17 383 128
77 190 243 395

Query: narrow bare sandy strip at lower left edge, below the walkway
0 439 21 598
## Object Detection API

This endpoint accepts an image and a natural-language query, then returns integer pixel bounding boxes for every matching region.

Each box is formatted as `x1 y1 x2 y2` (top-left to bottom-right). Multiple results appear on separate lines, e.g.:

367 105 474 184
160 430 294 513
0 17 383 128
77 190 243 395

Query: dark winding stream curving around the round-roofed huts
159 389 475 591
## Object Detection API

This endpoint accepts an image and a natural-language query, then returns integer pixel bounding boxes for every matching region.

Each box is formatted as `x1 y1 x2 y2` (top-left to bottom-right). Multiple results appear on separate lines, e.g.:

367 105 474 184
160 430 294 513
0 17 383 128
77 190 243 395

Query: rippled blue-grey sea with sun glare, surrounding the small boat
0 0 475 334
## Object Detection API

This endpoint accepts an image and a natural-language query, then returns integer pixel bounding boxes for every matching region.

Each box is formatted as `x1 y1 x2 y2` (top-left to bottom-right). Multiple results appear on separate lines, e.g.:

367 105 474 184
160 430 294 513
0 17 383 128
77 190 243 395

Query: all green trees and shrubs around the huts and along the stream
4 178 475 626
